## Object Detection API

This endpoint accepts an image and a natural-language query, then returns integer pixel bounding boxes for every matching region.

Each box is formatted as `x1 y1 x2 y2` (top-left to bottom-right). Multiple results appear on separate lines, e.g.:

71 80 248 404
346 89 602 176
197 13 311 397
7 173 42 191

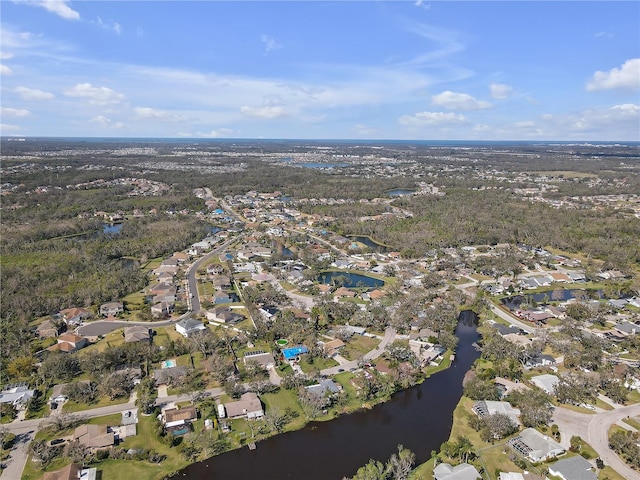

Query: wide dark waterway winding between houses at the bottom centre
176 312 480 480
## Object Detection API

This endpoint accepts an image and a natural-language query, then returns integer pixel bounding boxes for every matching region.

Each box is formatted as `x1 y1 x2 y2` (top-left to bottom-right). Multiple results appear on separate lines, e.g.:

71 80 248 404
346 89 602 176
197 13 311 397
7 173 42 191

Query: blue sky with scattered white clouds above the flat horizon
0 0 640 141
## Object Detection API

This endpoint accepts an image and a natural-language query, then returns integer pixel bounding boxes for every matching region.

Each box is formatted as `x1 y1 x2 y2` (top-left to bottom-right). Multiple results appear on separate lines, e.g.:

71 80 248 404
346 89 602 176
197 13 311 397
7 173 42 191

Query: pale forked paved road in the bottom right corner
553 404 640 480
